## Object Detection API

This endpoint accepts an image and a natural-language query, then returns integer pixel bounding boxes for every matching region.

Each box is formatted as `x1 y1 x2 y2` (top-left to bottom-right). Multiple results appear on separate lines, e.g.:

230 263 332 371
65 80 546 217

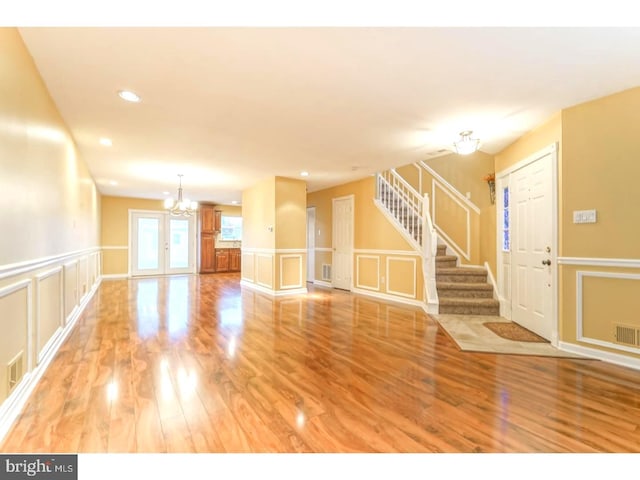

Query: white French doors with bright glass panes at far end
129 211 196 276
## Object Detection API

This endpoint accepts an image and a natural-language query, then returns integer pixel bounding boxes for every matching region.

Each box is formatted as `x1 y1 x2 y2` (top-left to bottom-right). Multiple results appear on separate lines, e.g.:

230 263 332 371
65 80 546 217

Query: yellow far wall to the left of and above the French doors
101 196 165 275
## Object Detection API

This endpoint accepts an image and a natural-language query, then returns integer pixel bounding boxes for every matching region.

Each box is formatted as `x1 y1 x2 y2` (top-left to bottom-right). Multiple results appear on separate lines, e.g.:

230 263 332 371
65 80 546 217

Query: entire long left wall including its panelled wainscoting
0 28 100 406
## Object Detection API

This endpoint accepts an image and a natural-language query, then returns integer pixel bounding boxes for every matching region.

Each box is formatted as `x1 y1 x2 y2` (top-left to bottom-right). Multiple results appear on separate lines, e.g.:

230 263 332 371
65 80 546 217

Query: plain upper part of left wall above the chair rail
0 28 100 266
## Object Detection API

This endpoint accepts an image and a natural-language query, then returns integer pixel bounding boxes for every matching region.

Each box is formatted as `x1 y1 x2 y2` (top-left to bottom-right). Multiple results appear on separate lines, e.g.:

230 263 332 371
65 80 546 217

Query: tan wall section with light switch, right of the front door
560 88 640 357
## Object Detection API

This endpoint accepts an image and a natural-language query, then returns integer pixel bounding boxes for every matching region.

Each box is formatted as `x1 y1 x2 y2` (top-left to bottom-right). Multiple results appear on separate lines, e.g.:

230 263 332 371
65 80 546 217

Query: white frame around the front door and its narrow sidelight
496 143 560 347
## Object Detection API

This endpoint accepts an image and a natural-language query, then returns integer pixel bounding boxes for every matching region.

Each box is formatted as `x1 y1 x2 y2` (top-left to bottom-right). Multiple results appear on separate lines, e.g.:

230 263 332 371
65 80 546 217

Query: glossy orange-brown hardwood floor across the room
1 274 640 453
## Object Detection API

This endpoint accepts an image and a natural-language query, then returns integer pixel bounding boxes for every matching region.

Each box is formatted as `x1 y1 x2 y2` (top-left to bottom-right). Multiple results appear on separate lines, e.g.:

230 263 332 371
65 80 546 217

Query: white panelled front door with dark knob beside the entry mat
510 154 556 340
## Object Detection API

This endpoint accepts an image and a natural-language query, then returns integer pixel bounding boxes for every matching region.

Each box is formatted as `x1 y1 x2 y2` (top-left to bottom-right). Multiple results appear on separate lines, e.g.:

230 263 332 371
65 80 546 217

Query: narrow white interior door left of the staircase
331 196 353 290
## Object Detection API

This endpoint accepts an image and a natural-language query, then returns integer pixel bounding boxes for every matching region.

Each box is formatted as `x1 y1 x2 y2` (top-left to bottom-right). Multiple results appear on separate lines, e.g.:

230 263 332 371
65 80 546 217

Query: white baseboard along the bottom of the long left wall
0 280 100 441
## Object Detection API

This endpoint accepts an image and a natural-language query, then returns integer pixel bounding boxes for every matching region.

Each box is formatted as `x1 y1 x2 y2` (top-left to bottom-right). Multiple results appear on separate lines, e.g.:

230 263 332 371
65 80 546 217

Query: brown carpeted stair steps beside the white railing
436 245 500 315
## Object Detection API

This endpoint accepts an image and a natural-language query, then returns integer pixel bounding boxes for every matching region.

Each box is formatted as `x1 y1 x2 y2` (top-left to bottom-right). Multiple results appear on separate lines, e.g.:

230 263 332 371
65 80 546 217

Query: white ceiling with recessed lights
20 27 640 204
